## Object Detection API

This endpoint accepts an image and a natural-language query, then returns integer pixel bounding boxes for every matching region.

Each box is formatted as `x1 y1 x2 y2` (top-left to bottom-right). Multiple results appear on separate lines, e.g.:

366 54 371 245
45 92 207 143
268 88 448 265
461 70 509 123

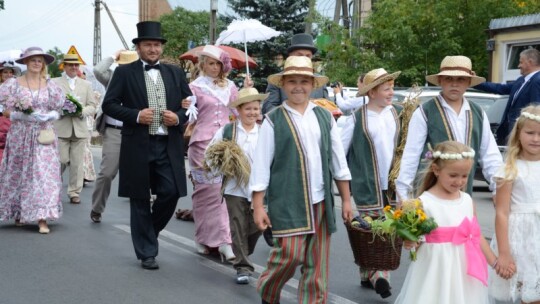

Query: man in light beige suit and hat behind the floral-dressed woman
53 54 96 204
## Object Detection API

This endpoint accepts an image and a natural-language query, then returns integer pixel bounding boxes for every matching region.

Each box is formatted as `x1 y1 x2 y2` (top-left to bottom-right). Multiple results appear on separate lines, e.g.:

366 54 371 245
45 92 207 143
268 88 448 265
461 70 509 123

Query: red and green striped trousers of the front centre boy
257 202 330 304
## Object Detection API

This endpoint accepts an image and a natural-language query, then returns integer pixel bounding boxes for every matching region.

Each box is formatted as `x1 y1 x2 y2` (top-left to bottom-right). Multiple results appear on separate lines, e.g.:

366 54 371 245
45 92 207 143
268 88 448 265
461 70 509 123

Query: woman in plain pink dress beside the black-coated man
188 45 238 260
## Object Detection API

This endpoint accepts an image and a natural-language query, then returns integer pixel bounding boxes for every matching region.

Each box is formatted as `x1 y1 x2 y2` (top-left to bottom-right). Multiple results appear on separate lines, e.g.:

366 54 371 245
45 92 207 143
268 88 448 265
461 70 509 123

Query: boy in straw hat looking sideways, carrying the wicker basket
341 69 402 298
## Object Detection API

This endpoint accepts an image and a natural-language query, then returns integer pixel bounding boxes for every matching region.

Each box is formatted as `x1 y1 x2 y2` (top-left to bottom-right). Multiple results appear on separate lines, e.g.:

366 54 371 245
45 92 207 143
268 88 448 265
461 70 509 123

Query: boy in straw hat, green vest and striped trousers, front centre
250 56 352 303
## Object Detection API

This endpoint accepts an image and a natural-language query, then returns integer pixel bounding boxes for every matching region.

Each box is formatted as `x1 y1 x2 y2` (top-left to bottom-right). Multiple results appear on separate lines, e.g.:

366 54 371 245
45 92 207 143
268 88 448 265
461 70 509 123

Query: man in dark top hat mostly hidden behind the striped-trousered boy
262 34 328 114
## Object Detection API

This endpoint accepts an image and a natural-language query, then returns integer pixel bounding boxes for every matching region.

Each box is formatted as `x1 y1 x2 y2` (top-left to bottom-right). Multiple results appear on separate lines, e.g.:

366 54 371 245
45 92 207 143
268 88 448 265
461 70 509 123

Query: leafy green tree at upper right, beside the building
357 0 540 85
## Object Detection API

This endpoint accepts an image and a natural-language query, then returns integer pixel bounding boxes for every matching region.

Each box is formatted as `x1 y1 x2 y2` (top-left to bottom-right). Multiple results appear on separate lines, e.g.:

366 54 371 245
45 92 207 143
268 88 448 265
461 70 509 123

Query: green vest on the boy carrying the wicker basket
347 105 403 210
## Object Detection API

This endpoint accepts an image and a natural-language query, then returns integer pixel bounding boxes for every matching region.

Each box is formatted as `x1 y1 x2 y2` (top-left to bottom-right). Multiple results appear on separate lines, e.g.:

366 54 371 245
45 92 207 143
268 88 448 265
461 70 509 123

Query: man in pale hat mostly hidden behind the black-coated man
90 50 139 223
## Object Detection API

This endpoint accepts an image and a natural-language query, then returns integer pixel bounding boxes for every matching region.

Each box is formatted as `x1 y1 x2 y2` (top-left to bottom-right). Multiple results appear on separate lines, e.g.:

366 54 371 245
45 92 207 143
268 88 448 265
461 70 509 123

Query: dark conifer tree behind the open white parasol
225 0 313 91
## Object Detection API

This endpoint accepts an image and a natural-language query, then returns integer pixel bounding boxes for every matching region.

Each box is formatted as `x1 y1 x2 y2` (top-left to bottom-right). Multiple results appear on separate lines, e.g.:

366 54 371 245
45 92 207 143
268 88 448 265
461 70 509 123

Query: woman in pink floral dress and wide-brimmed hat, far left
0 47 64 234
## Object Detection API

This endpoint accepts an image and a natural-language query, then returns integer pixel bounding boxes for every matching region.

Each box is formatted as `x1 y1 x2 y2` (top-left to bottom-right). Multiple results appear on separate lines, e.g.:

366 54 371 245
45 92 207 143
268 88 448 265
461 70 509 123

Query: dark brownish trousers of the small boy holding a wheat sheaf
225 194 262 275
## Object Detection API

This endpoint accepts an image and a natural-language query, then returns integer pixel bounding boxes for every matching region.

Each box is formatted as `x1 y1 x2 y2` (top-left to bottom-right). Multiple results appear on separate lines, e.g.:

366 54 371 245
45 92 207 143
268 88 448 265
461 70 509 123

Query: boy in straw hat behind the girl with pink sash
396 56 502 200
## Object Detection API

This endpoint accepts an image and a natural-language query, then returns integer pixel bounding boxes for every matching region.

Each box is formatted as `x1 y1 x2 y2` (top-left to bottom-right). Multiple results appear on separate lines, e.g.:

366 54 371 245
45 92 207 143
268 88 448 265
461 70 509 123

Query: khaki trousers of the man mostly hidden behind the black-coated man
92 127 122 213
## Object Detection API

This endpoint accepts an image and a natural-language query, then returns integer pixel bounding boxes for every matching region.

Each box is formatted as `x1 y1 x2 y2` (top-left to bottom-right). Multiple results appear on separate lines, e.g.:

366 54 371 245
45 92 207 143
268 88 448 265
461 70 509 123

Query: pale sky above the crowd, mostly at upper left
0 0 335 65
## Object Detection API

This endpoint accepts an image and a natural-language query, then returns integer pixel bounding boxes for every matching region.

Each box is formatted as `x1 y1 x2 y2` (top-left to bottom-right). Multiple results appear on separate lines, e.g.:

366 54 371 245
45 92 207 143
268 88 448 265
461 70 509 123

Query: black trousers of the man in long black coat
130 136 180 260
